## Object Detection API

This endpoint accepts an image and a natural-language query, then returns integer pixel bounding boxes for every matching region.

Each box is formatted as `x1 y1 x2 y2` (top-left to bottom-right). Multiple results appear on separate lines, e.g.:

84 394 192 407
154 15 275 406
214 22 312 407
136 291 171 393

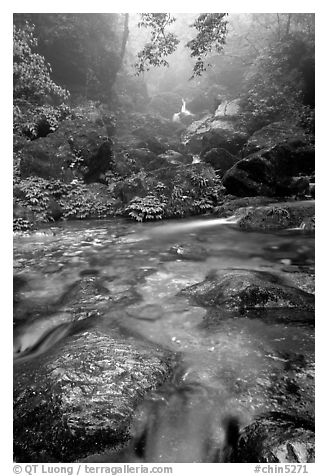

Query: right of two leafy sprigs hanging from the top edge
187 13 227 77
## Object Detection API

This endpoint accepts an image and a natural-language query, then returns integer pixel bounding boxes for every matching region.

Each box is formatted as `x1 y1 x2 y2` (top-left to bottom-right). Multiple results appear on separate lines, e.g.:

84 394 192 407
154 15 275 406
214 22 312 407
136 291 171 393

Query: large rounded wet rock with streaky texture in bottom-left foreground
14 330 172 462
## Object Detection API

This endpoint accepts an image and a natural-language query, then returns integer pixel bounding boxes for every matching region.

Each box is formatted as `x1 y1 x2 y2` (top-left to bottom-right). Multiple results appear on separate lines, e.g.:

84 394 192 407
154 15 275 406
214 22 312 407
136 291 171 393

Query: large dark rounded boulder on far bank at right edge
222 142 314 197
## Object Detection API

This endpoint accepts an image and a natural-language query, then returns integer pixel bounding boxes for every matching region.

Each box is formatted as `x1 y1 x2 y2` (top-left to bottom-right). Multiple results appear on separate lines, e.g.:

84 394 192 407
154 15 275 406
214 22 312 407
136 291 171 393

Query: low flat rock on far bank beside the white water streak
238 200 315 230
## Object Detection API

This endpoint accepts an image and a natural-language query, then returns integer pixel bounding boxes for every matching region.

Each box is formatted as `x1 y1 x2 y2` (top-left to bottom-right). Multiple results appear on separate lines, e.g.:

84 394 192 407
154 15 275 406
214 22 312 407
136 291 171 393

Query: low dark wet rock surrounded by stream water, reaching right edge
180 270 314 312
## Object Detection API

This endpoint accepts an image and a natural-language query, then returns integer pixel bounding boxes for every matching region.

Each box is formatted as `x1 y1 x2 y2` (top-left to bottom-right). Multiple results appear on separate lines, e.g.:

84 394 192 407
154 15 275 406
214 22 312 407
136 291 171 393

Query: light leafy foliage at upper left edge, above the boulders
13 22 68 103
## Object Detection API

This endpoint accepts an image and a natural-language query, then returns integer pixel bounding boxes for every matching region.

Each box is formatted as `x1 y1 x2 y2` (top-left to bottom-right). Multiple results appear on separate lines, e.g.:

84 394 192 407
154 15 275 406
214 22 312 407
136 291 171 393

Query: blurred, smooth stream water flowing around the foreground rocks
14 219 314 462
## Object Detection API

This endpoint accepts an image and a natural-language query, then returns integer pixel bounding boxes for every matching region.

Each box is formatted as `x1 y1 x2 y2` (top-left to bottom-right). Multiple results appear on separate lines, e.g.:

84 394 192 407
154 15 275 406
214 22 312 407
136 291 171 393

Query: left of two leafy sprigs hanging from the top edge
135 13 179 74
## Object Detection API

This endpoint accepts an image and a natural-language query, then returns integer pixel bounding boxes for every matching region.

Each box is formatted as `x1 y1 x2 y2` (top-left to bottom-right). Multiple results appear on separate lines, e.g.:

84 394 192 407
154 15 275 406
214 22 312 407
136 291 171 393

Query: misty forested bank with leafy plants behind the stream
13 13 314 229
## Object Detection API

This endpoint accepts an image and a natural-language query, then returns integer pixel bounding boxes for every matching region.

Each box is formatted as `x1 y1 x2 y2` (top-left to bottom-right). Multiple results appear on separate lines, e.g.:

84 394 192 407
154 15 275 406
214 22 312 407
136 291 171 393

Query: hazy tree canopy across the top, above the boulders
14 13 314 135
